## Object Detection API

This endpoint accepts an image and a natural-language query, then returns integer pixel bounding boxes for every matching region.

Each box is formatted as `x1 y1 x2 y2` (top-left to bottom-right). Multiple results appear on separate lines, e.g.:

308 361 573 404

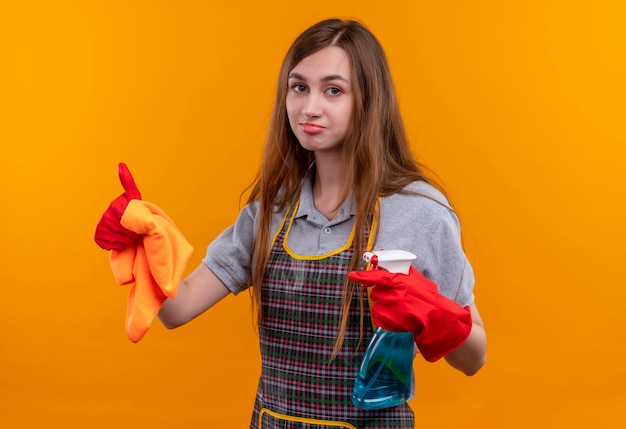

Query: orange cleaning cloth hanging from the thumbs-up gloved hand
110 200 193 343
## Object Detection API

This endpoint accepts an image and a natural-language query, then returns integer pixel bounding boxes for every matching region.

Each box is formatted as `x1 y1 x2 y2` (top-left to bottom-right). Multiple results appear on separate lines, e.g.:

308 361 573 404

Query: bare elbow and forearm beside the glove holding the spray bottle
445 304 487 375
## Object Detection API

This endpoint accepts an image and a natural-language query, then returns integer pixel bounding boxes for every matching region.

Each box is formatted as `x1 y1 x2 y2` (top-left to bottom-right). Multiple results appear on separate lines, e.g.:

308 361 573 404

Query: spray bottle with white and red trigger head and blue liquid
352 250 416 410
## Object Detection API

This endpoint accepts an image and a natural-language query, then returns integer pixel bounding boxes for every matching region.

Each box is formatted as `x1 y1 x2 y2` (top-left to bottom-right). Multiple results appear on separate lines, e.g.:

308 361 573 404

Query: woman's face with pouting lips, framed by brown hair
286 46 354 153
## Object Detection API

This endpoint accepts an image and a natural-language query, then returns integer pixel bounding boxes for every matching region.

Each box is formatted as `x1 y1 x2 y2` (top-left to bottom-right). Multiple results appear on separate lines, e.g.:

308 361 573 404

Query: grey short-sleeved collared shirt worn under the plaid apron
203 177 474 306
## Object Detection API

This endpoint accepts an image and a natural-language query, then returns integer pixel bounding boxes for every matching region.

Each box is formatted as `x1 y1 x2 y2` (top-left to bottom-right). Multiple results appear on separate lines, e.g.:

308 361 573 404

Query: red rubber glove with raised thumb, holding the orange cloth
94 163 141 251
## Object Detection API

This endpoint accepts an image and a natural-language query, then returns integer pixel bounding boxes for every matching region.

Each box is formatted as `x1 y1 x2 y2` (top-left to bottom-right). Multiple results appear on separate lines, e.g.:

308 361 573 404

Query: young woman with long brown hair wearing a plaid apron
98 19 486 429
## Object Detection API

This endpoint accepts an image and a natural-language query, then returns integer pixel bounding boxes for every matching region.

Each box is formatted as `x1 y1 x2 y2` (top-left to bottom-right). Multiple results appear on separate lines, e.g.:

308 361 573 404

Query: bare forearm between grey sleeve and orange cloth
159 264 230 329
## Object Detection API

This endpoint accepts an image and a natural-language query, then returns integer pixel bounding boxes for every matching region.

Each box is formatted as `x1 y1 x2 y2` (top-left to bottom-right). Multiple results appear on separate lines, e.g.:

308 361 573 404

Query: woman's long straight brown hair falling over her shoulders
248 19 431 357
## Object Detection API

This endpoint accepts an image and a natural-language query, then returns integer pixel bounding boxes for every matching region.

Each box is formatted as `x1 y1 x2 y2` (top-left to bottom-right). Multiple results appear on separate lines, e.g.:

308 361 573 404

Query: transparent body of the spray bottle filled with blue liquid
352 328 415 410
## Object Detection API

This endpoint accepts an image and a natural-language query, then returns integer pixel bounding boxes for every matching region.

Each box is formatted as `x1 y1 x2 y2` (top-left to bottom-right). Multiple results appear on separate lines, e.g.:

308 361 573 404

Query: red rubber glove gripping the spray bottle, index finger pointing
348 267 472 362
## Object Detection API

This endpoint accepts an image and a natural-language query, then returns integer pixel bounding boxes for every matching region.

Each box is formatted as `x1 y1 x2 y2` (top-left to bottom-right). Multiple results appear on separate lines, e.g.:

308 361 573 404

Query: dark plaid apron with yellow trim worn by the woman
250 204 414 429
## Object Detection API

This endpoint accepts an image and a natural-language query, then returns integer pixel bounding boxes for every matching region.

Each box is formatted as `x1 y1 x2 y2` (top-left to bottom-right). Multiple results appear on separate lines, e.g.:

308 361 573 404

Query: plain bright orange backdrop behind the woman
0 0 626 429
